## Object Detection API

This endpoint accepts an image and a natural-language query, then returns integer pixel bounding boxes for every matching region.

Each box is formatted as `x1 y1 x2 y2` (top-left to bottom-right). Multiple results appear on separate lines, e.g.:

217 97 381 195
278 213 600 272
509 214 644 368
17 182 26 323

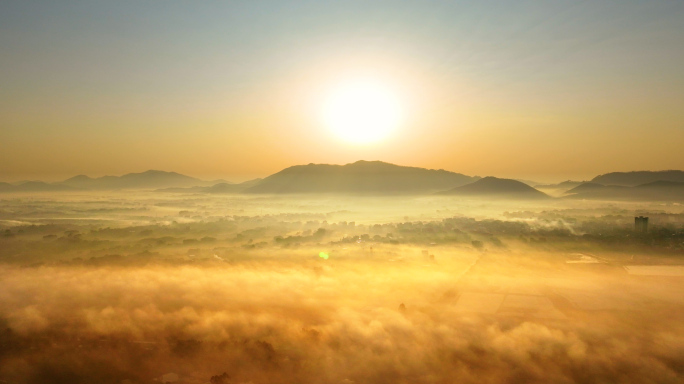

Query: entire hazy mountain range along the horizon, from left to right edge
0 161 684 201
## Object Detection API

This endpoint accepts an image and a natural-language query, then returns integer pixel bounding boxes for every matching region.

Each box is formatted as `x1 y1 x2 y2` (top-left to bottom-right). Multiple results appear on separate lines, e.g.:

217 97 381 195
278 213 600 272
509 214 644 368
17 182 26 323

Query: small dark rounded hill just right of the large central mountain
440 176 550 200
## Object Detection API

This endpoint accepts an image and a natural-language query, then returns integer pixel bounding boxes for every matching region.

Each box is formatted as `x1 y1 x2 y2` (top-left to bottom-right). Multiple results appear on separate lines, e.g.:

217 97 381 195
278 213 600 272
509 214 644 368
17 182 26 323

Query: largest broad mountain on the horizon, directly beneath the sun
245 161 477 194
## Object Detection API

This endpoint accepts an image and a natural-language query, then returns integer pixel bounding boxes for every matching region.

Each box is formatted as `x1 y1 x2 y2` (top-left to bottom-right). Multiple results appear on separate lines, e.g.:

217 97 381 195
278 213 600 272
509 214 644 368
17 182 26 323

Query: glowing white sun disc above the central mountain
322 80 402 144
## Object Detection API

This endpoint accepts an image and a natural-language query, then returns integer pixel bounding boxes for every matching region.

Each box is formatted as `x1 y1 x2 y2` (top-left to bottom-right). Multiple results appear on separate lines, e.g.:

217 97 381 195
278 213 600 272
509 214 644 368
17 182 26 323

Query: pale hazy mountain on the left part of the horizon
61 170 208 189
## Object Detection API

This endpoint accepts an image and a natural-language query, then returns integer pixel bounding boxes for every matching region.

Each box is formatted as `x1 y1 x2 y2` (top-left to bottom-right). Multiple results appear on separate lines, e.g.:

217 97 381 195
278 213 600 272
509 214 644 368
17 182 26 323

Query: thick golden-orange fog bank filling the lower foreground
0 254 684 384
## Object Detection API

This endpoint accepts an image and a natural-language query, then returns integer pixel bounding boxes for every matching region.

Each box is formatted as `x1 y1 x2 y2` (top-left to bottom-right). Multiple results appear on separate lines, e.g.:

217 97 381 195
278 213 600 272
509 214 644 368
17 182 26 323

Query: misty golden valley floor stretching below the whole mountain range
0 192 684 384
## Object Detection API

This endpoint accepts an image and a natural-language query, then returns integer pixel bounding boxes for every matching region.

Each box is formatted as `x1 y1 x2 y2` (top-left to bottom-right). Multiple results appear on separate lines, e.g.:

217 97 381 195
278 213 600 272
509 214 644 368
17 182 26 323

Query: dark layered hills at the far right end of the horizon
566 181 684 201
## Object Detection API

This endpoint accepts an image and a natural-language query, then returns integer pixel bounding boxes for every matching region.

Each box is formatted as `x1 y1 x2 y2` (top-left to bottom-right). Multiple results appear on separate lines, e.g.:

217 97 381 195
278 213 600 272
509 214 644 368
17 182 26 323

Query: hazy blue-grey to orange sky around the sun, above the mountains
0 0 684 181
